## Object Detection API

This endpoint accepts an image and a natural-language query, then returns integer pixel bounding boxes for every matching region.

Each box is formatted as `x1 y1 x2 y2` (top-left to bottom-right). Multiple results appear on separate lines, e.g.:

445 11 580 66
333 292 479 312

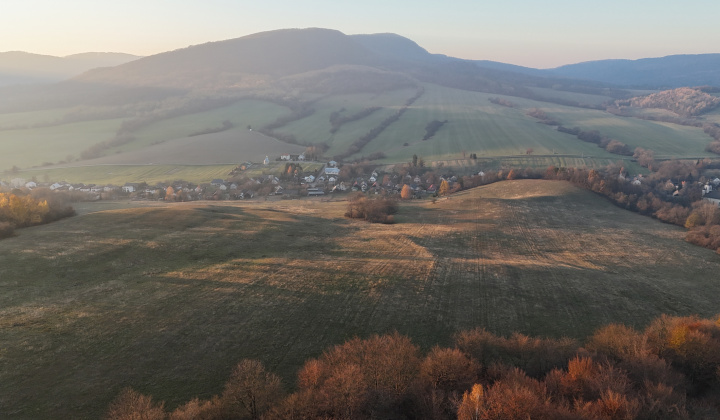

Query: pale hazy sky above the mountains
0 0 720 68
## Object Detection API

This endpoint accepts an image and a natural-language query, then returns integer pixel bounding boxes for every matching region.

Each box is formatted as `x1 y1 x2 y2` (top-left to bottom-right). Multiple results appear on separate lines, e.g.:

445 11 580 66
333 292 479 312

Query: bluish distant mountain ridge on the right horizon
546 54 720 89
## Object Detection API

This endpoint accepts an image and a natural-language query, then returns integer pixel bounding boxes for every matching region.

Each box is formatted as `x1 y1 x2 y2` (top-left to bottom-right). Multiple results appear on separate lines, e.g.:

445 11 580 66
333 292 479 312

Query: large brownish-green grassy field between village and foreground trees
0 181 720 419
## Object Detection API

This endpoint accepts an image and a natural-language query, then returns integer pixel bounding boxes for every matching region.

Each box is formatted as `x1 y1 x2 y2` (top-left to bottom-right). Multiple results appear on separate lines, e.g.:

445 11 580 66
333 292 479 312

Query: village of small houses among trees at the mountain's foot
0 154 470 201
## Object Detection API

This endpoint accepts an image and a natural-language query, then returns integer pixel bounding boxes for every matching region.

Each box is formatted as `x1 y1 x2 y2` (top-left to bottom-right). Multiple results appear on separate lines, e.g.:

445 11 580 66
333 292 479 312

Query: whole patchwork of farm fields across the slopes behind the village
0 84 708 178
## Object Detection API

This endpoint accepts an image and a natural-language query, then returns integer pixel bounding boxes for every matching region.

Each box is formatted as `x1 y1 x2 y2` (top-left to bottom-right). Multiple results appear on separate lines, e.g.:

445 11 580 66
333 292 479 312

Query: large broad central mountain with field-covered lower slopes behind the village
0 28 712 177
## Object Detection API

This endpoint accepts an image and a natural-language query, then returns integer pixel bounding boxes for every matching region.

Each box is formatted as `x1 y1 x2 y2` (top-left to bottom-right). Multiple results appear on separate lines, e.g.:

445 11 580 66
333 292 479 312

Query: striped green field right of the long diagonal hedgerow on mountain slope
360 85 613 161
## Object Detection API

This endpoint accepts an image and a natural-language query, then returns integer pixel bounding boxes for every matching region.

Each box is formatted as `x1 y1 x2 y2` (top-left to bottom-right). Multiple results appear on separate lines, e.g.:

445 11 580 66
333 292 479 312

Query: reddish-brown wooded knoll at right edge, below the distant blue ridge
615 87 720 117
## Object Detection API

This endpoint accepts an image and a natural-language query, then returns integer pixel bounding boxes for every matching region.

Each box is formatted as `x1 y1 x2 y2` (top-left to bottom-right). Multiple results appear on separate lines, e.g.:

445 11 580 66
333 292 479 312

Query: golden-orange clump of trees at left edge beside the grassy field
0 189 75 238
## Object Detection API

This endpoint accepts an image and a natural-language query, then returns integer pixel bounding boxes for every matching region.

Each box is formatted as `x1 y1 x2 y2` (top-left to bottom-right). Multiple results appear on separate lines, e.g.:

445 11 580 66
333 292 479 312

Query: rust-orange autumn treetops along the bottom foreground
106 315 720 420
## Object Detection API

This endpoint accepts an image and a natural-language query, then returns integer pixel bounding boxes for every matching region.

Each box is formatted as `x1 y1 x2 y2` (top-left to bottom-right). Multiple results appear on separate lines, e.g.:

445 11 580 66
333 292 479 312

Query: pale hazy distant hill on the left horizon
0 51 140 86
